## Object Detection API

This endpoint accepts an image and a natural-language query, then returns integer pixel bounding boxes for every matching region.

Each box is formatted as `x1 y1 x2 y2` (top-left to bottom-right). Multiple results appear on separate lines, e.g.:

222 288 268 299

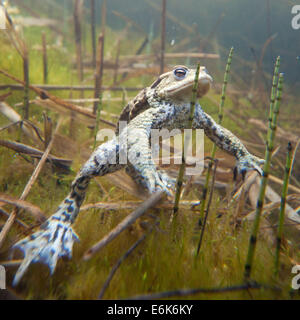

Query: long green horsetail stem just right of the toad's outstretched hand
244 69 283 281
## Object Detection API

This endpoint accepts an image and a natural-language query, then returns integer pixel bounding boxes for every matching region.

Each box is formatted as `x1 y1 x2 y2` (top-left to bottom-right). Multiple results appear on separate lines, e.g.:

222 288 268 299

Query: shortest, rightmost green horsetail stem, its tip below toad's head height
274 142 293 276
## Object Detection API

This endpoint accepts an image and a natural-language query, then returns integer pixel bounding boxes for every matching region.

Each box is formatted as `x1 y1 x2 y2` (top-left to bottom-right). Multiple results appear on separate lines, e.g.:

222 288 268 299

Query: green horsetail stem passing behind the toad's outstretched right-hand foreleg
197 48 233 255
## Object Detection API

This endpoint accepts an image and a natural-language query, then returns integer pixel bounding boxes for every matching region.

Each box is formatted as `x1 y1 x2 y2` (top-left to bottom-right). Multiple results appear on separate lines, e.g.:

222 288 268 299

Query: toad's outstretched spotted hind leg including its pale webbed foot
13 140 121 285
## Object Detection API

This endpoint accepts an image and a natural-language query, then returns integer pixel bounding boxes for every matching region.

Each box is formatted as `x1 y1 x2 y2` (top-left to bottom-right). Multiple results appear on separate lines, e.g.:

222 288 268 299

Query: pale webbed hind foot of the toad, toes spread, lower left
13 215 79 286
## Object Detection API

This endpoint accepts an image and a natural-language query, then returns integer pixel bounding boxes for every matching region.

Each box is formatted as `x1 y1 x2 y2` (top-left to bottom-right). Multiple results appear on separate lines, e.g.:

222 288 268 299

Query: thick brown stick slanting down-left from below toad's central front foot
83 190 165 260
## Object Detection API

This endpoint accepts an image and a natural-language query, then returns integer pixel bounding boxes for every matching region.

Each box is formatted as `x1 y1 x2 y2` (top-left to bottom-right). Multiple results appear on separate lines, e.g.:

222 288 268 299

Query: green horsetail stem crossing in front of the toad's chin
173 63 200 216
